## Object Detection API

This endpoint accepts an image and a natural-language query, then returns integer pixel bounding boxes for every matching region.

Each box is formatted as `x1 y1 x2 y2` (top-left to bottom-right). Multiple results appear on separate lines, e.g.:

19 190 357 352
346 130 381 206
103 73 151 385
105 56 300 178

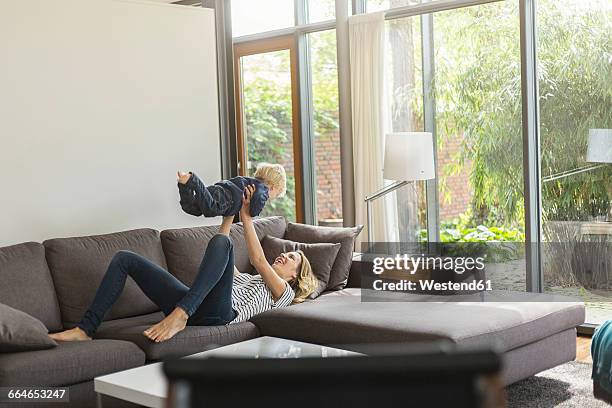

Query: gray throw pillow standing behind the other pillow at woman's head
284 222 363 290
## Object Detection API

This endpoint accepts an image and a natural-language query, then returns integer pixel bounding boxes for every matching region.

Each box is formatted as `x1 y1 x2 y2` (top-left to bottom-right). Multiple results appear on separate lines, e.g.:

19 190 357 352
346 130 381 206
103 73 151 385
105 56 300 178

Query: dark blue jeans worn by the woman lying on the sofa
77 234 236 336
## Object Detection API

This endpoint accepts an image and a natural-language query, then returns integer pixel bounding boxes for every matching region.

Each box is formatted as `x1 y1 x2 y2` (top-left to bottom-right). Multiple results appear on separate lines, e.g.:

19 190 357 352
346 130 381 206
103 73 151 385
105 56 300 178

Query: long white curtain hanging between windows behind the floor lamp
349 13 386 245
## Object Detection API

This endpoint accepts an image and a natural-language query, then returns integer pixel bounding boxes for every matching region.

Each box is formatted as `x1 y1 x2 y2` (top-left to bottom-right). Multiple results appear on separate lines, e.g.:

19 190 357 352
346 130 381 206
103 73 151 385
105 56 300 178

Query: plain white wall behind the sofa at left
0 0 221 246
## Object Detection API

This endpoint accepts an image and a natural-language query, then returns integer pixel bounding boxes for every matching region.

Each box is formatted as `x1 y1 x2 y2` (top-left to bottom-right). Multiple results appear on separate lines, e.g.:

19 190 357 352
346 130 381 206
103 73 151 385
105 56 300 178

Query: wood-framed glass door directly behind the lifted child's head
235 36 303 221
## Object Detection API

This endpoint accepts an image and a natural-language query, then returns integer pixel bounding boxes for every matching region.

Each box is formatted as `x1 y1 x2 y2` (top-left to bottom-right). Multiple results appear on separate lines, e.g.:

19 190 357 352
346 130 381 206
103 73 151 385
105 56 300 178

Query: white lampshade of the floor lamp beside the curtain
383 132 436 181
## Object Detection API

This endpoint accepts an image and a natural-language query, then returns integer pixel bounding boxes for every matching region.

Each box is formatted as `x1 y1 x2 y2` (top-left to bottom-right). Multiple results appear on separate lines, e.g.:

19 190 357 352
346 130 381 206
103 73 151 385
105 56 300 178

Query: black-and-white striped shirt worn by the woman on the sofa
230 273 295 324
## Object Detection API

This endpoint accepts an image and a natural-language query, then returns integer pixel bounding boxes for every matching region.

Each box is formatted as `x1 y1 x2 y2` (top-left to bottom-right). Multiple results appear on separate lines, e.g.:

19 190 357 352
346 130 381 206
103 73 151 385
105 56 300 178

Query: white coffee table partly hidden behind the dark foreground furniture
94 337 359 408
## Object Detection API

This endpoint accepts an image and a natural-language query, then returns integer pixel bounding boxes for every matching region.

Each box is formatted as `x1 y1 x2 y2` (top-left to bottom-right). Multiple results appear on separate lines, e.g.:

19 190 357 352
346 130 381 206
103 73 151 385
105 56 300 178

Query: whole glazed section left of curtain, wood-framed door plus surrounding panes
232 0 342 225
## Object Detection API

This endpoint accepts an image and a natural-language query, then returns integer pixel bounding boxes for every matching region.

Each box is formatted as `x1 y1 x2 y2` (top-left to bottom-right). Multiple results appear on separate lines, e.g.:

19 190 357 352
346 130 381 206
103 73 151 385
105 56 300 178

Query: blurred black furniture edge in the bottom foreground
164 347 504 408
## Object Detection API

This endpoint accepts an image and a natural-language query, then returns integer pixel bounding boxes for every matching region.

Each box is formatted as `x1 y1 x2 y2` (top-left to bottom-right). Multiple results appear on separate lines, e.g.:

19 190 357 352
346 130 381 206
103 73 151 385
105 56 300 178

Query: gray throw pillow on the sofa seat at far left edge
0 303 57 353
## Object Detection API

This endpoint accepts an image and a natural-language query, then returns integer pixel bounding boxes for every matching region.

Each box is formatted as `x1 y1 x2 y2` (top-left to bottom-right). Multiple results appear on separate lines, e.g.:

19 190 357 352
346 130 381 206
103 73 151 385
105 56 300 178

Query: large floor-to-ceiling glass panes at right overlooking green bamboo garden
376 0 612 316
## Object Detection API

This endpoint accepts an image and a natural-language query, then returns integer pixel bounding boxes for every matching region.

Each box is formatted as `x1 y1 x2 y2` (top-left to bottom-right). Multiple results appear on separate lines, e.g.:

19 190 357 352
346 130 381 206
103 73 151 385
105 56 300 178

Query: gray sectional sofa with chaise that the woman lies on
0 217 584 407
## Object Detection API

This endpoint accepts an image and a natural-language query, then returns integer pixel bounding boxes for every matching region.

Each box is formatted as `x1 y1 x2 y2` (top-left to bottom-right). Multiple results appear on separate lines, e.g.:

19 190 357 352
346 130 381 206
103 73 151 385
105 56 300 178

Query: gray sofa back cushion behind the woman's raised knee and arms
161 217 286 285
